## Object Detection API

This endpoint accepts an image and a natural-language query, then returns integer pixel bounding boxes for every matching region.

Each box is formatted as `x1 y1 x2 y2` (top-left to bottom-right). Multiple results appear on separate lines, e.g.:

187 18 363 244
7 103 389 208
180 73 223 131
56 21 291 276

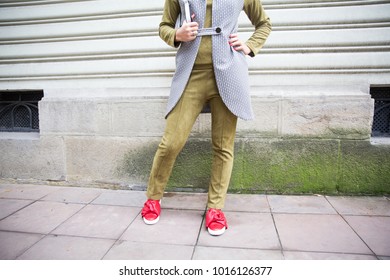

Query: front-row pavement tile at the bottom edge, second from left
18 235 115 260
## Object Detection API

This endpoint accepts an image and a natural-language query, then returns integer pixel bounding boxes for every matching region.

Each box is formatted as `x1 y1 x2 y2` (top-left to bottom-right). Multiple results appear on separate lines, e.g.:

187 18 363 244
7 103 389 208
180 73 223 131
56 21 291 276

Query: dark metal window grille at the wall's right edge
370 87 390 137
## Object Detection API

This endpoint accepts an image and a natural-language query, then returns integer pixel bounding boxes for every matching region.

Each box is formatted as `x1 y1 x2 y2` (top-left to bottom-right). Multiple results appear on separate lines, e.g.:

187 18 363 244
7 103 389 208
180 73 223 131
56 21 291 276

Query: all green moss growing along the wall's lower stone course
121 139 390 195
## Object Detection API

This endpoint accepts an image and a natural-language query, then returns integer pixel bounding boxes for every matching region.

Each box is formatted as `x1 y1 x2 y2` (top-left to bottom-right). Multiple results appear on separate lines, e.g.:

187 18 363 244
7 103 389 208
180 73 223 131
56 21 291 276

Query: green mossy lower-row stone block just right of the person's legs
231 140 338 193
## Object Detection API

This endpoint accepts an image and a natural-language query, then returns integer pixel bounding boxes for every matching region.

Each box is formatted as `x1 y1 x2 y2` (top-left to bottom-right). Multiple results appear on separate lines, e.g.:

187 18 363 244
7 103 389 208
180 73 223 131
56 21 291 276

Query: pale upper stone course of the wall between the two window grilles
39 85 374 139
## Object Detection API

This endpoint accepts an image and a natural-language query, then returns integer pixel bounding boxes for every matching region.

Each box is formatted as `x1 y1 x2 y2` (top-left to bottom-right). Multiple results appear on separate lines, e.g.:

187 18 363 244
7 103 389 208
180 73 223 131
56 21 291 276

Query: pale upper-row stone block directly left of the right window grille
281 96 373 139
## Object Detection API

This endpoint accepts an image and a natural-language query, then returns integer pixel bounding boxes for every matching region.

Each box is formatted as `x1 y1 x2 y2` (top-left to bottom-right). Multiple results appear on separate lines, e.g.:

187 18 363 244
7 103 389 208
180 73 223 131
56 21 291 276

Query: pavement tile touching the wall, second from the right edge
268 195 336 214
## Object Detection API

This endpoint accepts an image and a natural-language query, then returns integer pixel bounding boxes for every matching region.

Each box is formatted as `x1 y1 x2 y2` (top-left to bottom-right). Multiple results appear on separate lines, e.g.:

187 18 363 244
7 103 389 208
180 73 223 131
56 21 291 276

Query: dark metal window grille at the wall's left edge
0 91 43 132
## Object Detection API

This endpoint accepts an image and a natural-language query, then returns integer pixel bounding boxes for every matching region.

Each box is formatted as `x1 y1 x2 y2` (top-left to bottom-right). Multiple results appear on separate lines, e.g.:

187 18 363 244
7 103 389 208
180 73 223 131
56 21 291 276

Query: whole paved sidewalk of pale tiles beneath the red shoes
0 184 390 260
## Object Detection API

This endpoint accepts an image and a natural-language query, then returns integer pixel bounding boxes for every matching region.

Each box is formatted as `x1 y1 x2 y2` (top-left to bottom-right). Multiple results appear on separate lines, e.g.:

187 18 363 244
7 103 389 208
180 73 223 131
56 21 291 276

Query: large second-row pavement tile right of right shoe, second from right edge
274 214 372 254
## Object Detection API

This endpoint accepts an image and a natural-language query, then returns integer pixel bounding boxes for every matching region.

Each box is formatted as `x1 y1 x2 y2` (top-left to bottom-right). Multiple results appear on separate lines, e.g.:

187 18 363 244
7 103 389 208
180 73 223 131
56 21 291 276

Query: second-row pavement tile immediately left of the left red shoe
53 205 140 239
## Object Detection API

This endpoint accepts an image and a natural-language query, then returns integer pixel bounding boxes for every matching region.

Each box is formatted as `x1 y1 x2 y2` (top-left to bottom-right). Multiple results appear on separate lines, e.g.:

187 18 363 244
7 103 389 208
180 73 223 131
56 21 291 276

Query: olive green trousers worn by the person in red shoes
146 69 237 209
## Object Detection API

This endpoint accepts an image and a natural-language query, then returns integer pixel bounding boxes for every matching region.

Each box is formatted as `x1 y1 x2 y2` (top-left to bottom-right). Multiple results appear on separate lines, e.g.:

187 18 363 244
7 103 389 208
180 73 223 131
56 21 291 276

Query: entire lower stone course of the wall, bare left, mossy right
0 136 390 195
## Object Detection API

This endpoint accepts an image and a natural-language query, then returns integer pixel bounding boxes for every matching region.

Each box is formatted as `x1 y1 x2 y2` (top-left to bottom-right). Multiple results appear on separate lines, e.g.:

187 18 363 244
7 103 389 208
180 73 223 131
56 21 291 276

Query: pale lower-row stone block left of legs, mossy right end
65 136 157 184
